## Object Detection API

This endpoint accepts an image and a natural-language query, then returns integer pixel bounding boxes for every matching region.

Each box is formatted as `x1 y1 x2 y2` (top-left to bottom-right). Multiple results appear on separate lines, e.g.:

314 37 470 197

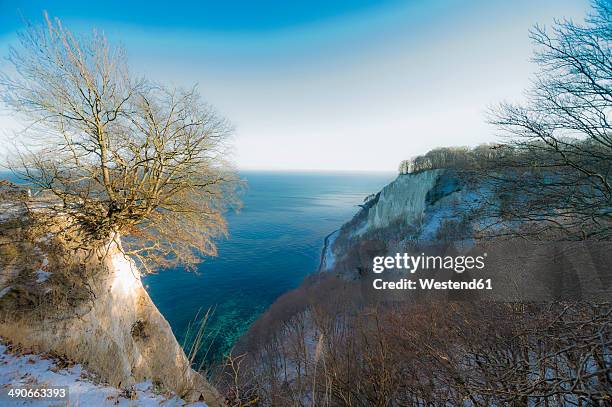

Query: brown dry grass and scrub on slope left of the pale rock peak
0 216 101 326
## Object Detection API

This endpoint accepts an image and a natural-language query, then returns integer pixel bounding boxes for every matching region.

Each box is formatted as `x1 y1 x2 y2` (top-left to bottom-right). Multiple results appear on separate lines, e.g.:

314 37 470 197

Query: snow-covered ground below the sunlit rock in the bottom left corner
0 343 206 407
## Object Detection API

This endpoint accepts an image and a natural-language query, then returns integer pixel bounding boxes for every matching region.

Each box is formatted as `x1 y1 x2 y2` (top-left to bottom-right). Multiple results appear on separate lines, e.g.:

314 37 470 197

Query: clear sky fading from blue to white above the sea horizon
0 0 589 171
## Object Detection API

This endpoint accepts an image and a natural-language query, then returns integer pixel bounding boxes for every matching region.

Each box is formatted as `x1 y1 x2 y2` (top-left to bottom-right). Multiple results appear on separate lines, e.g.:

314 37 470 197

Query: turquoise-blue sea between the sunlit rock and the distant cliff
144 172 395 361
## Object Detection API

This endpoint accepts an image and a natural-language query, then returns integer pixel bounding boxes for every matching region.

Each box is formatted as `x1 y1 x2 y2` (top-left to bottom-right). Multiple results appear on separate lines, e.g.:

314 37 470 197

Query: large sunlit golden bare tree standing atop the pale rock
0 15 239 270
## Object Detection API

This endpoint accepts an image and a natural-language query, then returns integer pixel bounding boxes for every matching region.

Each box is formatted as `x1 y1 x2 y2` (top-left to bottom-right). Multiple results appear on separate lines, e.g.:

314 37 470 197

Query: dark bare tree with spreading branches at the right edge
487 0 612 240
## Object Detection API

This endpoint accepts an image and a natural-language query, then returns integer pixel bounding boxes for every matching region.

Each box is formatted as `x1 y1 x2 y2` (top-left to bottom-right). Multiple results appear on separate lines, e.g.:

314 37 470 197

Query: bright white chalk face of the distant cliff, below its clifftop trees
356 170 441 235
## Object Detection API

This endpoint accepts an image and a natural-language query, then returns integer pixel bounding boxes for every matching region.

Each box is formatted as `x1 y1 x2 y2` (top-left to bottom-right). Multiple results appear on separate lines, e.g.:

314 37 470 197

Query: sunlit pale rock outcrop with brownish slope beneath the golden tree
0 231 223 406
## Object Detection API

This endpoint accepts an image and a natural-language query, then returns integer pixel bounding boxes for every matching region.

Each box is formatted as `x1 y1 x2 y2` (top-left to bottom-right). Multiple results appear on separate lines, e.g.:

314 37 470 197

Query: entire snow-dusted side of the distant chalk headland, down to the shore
320 170 464 275
